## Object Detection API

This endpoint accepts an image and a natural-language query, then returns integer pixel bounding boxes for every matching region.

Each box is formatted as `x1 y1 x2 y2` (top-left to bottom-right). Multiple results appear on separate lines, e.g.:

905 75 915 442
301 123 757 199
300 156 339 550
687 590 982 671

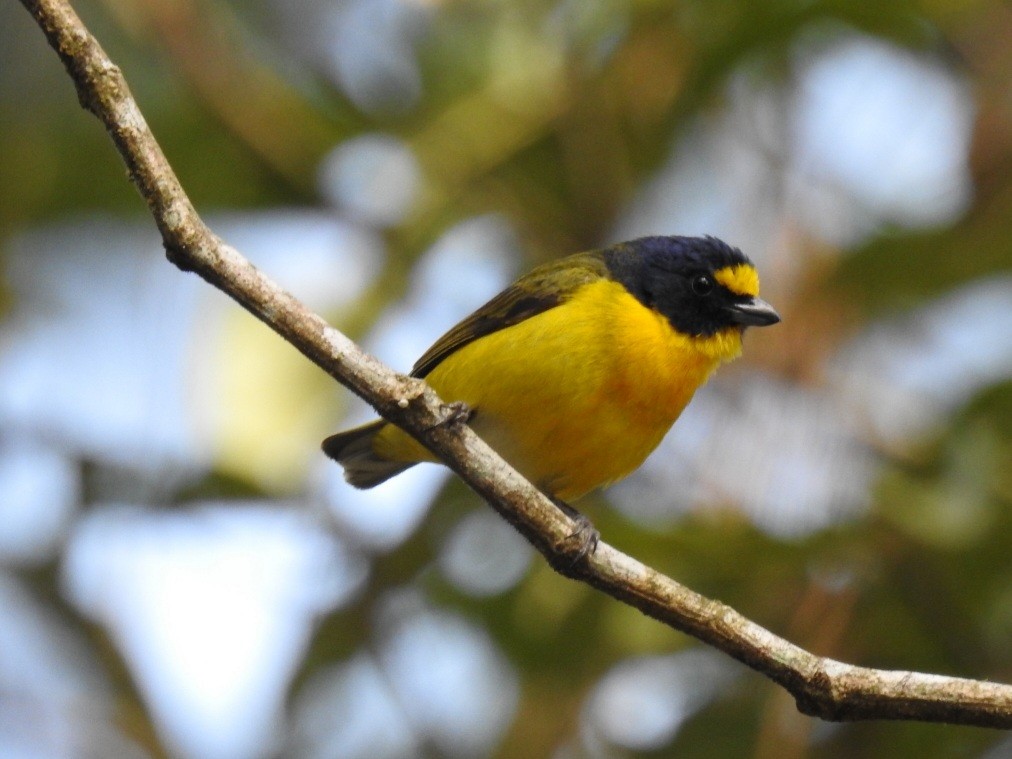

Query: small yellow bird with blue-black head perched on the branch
322 236 780 553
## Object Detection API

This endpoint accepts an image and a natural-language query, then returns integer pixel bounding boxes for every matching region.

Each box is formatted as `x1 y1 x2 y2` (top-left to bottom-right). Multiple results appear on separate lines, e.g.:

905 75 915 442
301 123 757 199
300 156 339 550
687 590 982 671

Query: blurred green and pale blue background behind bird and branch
0 0 1012 759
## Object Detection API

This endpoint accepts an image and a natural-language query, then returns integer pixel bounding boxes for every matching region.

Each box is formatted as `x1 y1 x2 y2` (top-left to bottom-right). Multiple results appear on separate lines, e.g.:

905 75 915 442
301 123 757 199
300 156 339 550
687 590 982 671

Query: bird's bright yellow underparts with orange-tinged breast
374 280 742 500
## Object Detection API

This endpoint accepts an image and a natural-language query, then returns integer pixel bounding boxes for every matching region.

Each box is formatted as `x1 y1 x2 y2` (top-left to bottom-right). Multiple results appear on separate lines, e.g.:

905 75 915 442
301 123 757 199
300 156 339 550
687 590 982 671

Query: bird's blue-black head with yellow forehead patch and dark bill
603 237 780 337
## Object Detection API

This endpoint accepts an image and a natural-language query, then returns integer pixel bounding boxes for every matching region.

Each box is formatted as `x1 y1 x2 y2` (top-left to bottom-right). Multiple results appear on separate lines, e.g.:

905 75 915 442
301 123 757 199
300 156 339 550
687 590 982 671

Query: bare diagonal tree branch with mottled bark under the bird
21 0 1012 729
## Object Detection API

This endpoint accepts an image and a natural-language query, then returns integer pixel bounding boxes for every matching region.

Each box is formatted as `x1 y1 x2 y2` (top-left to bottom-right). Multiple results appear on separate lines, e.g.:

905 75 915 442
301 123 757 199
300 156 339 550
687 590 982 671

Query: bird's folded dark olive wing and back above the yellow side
411 252 608 377
